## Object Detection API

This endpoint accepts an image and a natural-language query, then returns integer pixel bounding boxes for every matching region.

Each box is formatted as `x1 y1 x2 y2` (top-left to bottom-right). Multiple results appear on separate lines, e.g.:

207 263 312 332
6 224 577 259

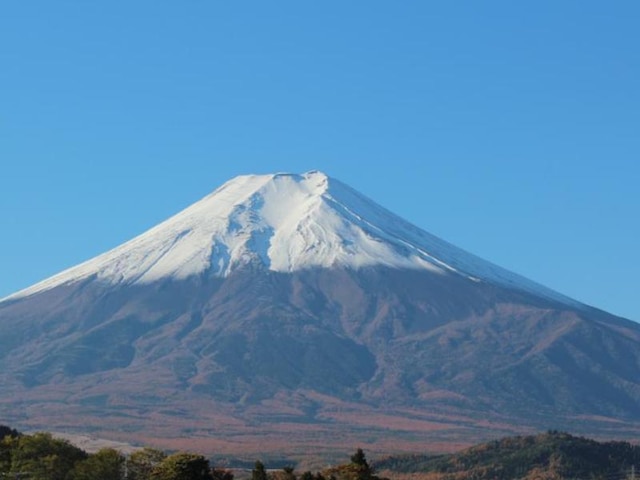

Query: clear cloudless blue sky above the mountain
0 0 640 321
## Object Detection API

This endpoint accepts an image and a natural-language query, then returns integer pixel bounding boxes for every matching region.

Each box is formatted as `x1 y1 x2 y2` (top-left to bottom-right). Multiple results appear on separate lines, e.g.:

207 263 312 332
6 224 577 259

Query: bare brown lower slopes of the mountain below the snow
0 265 640 458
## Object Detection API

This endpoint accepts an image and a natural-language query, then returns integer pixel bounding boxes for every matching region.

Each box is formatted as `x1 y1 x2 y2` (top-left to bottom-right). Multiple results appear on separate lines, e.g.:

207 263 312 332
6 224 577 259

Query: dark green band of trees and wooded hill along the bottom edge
0 425 640 480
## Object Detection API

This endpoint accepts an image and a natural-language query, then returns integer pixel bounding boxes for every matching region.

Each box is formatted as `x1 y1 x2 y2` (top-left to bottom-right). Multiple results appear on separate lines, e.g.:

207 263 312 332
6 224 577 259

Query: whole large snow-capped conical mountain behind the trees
0 172 640 453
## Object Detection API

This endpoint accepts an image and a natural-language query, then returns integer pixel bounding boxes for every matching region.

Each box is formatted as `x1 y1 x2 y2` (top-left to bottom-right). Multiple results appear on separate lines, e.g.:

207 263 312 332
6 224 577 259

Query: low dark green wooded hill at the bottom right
375 431 640 480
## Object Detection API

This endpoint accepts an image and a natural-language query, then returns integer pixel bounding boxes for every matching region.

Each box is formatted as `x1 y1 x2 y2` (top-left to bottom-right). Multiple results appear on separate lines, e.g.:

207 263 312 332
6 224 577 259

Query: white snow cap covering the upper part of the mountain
5 171 577 305
